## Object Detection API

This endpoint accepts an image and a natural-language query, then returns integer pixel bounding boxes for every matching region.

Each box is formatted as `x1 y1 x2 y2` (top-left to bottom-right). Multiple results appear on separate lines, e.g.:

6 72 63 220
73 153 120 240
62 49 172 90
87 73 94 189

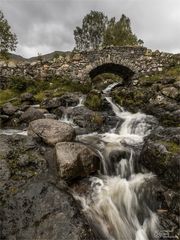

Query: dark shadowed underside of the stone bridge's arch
89 63 135 82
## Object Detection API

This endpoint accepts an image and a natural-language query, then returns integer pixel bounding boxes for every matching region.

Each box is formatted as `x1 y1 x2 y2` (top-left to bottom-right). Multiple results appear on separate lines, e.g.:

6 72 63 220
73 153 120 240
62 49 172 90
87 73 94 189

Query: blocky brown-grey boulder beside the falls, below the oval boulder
56 142 100 180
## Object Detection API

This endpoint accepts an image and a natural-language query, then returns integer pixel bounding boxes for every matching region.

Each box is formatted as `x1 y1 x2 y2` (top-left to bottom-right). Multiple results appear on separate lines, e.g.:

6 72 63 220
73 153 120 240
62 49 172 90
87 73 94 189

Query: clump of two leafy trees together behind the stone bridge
74 11 143 51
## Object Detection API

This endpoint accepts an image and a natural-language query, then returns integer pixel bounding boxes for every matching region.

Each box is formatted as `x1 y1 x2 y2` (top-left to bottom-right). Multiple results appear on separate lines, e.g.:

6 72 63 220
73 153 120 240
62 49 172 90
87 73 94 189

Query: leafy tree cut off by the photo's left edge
0 10 17 56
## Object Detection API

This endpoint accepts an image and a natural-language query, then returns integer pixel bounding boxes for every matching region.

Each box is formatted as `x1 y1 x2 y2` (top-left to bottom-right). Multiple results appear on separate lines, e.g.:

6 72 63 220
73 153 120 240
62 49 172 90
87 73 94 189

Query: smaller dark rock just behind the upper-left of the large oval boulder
20 107 44 123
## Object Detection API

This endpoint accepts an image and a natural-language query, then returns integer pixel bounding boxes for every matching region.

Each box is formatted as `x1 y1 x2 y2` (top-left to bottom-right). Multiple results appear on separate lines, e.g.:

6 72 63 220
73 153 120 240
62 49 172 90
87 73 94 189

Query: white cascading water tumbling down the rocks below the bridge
75 83 158 240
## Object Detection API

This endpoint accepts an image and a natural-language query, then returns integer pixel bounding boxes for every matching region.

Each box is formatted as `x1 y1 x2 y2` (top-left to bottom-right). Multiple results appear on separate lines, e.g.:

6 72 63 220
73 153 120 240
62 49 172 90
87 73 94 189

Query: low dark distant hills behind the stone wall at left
10 51 70 62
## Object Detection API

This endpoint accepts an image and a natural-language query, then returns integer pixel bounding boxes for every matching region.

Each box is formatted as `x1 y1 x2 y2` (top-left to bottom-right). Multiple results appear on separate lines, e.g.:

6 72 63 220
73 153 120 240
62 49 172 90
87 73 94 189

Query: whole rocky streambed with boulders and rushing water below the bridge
0 81 180 240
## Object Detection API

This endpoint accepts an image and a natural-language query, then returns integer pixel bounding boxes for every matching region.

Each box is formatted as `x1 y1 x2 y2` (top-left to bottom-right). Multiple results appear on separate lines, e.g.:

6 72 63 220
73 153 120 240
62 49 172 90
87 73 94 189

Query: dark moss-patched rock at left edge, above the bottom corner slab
0 134 47 205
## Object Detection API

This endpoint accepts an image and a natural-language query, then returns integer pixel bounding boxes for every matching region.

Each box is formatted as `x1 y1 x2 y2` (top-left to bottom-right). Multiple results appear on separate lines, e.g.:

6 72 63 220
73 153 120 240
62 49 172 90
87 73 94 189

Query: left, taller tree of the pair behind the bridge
74 11 108 50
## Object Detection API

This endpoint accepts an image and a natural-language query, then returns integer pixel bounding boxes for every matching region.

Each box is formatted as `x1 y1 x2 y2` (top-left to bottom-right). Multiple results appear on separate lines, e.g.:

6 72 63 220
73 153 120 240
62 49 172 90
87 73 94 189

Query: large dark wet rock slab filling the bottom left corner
1 179 97 240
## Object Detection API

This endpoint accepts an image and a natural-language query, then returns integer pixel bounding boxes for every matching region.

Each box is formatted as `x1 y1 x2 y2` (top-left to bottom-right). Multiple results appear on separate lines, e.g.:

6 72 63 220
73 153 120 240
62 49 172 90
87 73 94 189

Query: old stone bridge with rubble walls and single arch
0 47 175 88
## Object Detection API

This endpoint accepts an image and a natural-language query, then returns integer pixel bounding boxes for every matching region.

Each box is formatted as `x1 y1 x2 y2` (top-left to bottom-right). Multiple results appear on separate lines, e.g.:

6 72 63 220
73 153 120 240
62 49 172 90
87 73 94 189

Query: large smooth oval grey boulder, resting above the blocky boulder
28 119 75 145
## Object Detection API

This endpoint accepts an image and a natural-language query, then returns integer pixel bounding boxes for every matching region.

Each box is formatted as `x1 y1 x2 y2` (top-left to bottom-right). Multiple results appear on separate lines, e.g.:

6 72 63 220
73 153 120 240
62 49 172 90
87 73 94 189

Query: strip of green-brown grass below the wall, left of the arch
0 76 91 106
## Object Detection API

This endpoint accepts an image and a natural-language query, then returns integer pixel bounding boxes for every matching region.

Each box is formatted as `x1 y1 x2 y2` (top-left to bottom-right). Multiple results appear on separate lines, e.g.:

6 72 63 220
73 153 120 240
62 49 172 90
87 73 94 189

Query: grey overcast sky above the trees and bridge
0 0 180 57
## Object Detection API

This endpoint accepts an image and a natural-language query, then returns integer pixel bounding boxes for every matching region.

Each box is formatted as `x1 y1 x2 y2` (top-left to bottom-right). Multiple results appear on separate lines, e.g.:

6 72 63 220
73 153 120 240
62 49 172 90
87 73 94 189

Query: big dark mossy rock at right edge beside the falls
140 128 180 189
